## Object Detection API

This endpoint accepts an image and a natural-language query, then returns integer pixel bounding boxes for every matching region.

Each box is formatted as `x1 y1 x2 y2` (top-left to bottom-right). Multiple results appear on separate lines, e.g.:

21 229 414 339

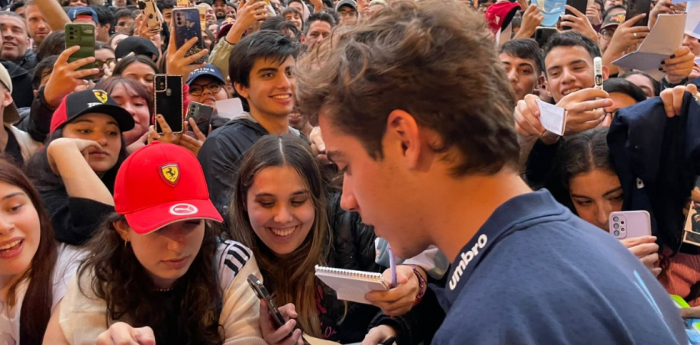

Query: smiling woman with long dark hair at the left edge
0 159 80 344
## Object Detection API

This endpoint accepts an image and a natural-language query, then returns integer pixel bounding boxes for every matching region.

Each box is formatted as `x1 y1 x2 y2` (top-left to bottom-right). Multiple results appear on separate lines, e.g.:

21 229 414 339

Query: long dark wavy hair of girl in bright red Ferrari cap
78 213 223 344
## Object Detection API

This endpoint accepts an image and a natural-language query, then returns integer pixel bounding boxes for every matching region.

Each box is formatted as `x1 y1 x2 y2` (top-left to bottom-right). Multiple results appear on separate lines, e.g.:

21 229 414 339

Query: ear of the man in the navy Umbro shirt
383 110 429 170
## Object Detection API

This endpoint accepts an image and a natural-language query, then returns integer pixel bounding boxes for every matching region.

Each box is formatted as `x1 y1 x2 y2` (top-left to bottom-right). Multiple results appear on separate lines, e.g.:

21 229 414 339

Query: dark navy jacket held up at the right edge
608 93 700 253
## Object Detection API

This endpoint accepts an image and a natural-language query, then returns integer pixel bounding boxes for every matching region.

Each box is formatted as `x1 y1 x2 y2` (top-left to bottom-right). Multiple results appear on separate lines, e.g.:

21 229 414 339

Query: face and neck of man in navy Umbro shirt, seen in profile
319 109 431 258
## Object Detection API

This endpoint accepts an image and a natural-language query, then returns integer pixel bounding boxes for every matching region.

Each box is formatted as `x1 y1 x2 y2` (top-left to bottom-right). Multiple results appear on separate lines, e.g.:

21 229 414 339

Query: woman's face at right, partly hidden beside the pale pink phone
569 169 623 231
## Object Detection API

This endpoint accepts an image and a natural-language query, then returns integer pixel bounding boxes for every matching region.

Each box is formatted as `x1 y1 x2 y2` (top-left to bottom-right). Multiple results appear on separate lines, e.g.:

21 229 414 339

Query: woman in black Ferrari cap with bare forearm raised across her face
27 89 134 245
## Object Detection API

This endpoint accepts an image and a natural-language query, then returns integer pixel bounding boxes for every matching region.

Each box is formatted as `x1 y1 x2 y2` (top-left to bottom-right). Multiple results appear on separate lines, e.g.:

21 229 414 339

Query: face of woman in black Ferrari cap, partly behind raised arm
63 113 122 173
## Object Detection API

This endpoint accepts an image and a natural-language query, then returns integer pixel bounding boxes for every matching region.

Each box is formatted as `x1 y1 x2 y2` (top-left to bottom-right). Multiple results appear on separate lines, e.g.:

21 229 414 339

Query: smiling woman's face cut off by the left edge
0 181 41 289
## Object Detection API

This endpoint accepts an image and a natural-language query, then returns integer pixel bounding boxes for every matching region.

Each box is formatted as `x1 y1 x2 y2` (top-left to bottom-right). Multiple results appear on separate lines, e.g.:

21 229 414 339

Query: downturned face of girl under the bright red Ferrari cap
114 219 204 289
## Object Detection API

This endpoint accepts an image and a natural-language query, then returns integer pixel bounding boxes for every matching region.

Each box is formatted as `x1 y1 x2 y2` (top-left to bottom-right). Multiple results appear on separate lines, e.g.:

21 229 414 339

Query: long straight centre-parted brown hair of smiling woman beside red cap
230 135 331 337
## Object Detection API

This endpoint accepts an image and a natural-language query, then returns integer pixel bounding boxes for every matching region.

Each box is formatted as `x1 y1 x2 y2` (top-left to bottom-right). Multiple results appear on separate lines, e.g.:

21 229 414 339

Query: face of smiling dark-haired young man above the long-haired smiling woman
234 56 296 117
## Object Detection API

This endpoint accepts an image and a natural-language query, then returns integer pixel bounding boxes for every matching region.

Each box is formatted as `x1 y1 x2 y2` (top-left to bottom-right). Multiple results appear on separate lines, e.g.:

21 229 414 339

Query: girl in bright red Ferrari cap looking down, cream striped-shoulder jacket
44 143 265 345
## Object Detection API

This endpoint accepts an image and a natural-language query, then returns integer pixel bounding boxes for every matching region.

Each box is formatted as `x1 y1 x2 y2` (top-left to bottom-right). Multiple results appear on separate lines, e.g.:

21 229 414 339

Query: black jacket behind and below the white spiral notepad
317 192 444 345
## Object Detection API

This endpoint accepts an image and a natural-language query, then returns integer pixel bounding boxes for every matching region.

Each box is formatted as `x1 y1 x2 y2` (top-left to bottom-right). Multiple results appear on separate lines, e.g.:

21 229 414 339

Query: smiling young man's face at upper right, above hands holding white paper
544 46 595 102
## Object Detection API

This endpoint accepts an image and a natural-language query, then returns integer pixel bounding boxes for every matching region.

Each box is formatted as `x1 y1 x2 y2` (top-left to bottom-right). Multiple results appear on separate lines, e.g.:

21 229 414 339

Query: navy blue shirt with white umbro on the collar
433 190 688 345
